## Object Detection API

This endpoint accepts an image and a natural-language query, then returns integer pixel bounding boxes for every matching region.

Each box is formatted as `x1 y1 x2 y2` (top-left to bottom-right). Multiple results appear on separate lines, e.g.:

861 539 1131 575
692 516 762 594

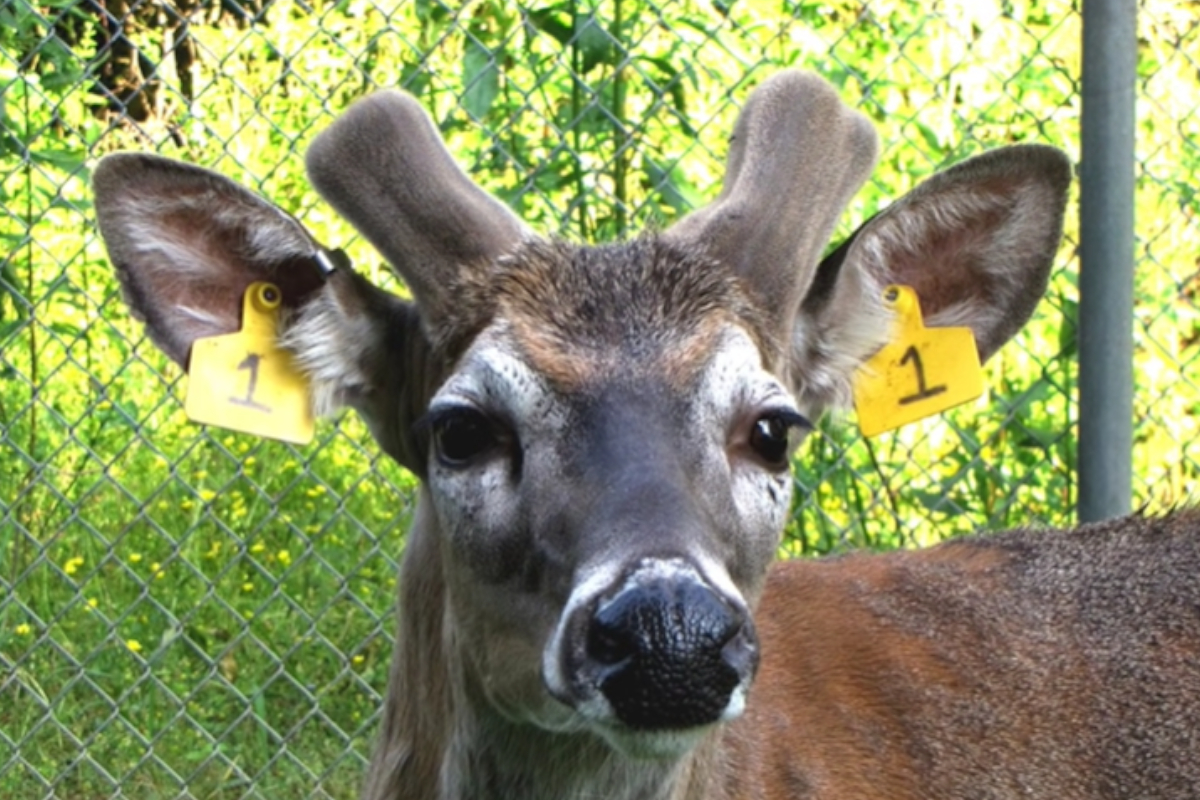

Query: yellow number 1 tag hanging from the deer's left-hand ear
184 282 313 445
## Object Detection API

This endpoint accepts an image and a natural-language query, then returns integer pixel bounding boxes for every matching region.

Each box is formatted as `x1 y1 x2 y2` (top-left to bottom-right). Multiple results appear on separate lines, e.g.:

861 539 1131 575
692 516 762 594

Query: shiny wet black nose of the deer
587 579 758 729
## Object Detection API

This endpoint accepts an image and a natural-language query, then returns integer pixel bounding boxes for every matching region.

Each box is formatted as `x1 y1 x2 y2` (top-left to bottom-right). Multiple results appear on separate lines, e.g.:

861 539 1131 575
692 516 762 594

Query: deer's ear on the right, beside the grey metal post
791 145 1072 408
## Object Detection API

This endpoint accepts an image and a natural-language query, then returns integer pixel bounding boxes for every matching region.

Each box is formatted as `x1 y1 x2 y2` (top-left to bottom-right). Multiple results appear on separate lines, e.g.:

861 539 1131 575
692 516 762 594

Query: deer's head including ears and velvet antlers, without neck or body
95 73 1069 756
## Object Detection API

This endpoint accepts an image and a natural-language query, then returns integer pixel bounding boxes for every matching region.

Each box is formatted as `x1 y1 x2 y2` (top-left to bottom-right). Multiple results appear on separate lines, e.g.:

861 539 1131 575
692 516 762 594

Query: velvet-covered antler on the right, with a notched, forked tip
665 71 878 324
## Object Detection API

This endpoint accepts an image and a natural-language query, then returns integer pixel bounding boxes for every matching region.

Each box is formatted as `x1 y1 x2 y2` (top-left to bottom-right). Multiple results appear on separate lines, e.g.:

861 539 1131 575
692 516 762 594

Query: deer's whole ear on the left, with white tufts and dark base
94 154 434 471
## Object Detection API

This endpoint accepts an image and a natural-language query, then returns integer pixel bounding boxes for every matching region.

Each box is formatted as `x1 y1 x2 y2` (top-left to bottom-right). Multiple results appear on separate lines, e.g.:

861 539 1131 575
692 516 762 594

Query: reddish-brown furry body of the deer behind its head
695 512 1200 800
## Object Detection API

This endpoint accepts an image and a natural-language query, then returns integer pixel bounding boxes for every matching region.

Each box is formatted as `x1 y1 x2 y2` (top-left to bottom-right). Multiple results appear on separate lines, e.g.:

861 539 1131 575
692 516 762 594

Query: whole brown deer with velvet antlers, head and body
94 71 1200 800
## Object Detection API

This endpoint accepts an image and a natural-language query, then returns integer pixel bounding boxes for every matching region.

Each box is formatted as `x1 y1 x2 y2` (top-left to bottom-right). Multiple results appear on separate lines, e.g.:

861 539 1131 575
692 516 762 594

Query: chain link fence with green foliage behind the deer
0 0 1200 800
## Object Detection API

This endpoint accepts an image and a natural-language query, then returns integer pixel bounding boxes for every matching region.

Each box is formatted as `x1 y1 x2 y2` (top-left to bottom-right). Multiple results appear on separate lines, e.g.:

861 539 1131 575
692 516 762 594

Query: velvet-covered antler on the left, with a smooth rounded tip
306 91 527 326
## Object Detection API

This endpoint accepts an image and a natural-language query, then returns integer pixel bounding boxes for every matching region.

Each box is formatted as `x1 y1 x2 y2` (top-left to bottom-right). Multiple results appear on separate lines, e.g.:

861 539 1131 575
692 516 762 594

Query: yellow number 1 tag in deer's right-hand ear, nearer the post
854 285 984 437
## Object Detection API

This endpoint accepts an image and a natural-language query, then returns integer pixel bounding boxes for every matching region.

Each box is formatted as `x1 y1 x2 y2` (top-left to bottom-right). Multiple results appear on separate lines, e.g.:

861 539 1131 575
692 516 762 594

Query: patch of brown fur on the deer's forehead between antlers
492 236 780 390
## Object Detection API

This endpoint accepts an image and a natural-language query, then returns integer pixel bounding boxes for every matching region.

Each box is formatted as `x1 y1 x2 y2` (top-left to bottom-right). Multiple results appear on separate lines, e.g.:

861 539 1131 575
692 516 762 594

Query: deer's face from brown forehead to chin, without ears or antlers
405 240 806 753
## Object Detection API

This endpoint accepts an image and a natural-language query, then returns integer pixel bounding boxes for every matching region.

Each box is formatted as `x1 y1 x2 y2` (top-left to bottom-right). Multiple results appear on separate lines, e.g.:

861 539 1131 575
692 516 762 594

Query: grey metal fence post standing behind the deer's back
1079 0 1138 522
